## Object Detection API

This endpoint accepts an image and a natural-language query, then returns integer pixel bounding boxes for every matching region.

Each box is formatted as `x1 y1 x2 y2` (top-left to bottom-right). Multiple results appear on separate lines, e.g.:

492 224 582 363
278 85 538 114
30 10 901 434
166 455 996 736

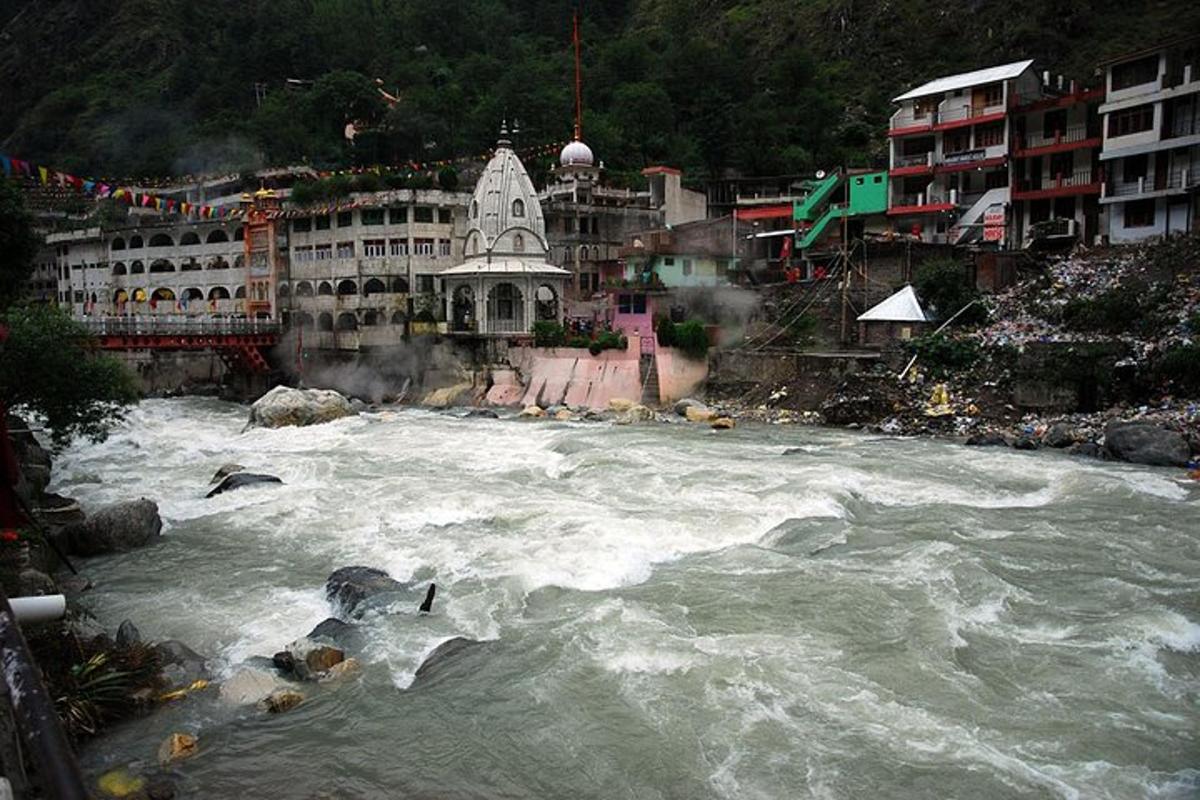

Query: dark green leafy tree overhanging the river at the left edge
0 180 137 446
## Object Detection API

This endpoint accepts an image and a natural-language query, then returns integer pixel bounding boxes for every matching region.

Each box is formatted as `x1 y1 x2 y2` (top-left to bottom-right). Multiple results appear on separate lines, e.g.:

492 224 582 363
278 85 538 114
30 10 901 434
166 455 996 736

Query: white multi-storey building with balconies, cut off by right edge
1100 35 1200 242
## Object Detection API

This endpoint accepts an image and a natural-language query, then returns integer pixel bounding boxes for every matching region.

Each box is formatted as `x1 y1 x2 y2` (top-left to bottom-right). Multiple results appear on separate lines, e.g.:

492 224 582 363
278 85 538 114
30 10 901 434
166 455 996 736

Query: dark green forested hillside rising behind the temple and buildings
0 0 1200 176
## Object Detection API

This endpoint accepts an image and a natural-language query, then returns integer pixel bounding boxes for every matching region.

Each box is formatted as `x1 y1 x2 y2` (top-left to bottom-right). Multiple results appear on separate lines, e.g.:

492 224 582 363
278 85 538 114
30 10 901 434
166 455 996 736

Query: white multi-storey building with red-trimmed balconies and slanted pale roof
888 61 1039 245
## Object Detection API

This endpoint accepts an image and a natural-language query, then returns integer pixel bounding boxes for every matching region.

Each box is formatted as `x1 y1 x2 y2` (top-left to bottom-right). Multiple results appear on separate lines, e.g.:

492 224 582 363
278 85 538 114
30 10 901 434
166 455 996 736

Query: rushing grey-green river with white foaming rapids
55 399 1200 799
